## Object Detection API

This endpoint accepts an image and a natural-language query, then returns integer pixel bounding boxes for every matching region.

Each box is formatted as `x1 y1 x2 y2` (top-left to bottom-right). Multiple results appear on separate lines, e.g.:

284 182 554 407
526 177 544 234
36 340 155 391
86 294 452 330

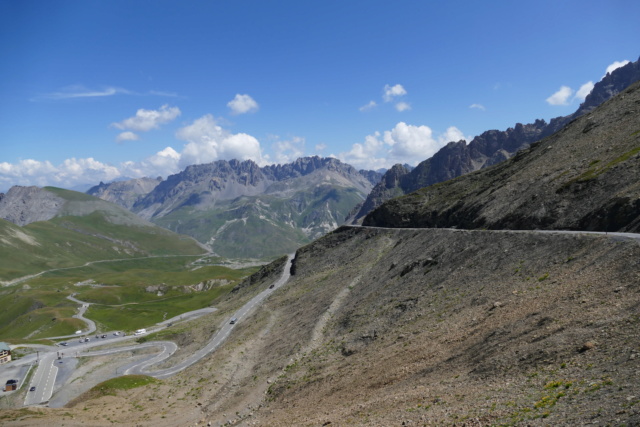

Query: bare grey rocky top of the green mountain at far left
0 185 65 226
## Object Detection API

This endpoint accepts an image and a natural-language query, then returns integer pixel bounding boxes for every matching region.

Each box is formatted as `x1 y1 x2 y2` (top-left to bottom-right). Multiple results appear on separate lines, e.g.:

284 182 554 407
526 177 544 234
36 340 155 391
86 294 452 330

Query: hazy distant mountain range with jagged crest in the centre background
91 156 381 258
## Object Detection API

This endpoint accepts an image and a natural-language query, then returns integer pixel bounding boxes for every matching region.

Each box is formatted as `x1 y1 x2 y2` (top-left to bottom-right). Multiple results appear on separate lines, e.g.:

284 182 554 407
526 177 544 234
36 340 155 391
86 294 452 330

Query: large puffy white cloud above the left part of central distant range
176 114 264 167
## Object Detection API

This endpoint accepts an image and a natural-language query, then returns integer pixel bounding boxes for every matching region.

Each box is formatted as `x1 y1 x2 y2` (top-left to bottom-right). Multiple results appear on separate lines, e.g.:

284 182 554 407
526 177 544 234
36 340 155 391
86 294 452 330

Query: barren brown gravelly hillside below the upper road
6 228 640 426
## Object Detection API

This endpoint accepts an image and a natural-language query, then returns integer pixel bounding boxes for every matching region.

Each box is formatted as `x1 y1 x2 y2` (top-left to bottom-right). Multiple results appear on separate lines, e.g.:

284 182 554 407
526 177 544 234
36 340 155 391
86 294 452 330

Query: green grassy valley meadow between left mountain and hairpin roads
0 257 256 340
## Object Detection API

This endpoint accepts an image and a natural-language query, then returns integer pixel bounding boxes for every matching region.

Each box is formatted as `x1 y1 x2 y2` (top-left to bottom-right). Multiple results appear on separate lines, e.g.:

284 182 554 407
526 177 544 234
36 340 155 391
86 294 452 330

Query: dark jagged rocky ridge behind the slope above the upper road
353 59 640 222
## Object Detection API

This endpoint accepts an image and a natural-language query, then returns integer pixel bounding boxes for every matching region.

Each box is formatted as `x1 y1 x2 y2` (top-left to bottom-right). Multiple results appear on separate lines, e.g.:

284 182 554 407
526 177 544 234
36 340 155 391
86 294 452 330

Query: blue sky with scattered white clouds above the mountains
0 0 640 191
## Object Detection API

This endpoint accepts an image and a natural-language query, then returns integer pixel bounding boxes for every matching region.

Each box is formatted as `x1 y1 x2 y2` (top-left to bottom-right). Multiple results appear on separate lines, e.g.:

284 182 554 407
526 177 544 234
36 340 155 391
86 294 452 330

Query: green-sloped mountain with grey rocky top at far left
0 187 205 282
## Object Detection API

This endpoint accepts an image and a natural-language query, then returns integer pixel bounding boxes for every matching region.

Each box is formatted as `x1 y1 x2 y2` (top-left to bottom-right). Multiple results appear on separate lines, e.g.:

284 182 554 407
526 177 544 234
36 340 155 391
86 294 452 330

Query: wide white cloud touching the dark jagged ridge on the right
337 122 464 169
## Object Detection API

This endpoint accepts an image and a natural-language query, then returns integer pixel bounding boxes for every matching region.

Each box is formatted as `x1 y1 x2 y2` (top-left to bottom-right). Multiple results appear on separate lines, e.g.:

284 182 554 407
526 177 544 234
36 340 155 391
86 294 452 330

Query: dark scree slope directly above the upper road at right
363 82 640 232
